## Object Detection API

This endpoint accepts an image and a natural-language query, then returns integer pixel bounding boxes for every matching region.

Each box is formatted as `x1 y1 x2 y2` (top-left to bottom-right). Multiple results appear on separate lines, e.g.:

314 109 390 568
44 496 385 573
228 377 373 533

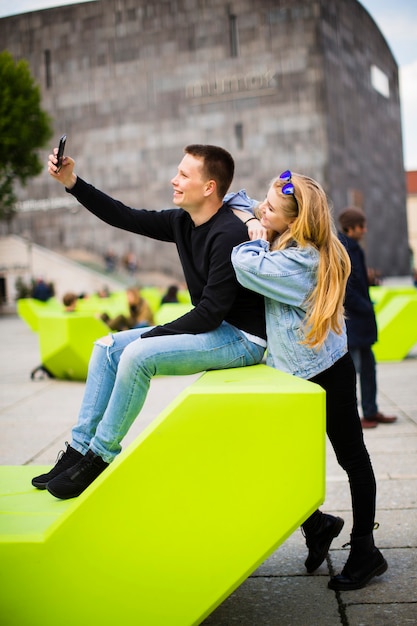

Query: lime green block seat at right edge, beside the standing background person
372 294 417 362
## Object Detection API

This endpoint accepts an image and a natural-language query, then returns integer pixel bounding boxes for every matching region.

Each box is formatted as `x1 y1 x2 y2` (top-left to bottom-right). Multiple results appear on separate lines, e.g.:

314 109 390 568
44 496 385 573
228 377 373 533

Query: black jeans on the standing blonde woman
310 353 376 537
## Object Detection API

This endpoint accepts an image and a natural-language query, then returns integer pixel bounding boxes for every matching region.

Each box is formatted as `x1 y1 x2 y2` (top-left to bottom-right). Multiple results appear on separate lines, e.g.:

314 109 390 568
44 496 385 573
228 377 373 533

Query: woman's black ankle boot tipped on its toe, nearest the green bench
302 511 345 574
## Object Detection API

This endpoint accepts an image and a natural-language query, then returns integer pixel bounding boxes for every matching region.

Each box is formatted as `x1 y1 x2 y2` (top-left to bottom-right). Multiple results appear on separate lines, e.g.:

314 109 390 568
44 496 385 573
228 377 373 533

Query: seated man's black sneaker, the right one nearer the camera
47 450 109 500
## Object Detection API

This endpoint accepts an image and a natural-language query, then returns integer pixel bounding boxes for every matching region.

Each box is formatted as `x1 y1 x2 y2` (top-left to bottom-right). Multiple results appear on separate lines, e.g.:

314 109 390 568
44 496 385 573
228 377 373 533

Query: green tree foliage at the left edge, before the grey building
0 50 52 221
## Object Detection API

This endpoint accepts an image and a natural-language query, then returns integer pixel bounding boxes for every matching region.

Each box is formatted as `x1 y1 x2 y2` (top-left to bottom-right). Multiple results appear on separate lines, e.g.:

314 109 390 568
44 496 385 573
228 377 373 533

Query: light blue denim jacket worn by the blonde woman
232 239 347 379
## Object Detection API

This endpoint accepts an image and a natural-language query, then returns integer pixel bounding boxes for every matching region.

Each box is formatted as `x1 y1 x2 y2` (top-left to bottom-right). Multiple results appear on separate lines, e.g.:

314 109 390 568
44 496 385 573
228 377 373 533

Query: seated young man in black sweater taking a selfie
32 145 266 499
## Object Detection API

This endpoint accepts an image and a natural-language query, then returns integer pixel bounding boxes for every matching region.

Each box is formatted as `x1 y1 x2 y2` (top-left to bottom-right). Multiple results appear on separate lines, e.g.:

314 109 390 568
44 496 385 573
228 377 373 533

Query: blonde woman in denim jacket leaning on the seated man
230 170 388 590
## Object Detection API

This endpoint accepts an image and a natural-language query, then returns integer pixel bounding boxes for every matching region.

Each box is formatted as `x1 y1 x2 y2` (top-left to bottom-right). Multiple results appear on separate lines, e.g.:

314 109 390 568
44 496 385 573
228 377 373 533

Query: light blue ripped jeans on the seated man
71 322 265 463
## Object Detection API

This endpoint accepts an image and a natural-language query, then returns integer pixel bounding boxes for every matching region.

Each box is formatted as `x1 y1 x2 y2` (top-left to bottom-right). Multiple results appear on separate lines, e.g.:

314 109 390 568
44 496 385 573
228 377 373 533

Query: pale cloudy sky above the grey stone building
0 0 417 170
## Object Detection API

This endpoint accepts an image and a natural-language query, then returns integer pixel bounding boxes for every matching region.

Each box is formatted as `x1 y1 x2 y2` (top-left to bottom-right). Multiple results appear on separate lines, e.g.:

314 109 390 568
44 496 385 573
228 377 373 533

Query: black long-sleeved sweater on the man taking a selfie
67 178 266 339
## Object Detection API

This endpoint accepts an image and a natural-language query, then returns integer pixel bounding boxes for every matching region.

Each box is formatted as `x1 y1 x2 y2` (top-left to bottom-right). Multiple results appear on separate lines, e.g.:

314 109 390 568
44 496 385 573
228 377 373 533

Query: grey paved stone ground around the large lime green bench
0 315 417 626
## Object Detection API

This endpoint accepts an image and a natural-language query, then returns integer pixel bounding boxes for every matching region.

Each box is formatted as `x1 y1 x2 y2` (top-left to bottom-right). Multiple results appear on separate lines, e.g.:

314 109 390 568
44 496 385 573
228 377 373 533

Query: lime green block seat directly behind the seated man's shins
38 313 109 380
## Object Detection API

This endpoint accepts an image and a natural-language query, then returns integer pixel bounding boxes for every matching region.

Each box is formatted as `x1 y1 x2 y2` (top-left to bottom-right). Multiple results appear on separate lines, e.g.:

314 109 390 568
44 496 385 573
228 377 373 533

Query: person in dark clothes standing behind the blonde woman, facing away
339 207 397 428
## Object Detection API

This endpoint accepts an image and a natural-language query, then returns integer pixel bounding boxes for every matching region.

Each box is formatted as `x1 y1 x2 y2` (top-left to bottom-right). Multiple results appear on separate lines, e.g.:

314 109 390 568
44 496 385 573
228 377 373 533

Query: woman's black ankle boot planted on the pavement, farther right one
328 533 388 591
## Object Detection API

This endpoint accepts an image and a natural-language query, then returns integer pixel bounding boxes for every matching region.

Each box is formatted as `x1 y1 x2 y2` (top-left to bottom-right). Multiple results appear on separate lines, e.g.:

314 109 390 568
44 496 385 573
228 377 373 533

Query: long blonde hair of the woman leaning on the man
264 173 350 348
